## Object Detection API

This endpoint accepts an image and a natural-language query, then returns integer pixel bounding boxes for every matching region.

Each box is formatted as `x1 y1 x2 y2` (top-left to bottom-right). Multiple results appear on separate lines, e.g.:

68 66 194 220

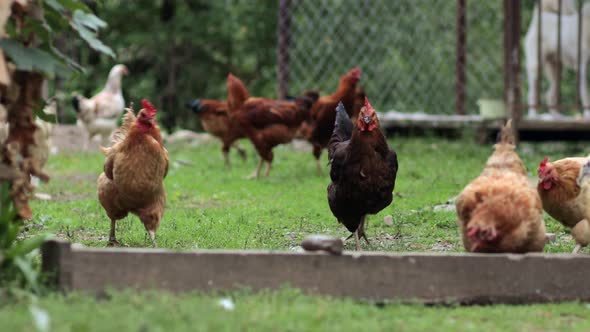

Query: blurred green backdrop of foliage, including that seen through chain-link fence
54 0 575 130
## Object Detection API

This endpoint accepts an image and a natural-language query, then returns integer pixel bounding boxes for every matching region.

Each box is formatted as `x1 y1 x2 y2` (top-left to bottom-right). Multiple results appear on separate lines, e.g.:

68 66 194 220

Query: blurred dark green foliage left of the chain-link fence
61 0 277 129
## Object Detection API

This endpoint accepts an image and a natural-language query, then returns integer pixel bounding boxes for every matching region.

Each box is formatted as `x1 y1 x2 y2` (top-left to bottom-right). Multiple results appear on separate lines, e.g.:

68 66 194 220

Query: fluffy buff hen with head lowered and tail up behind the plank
456 120 546 253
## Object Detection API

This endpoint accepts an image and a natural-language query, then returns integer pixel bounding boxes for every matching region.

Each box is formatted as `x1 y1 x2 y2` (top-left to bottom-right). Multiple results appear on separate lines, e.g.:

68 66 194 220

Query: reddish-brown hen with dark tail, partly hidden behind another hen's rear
186 99 246 166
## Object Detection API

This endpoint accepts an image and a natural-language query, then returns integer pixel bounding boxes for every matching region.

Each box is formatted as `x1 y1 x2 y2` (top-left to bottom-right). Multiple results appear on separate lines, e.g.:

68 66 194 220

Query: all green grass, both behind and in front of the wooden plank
0 138 590 331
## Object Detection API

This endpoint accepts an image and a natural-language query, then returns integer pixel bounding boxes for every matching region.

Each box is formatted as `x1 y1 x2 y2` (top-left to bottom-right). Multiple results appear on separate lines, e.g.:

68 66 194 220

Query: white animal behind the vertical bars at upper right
524 0 590 117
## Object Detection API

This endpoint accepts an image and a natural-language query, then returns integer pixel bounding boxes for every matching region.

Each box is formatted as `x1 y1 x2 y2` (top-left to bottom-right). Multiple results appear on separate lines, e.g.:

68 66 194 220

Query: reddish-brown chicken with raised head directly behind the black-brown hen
303 68 361 173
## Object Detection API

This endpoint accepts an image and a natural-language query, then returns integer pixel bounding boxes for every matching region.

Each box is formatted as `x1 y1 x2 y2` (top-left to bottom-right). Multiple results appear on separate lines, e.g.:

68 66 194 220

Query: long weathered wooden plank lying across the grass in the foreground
43 241 590 303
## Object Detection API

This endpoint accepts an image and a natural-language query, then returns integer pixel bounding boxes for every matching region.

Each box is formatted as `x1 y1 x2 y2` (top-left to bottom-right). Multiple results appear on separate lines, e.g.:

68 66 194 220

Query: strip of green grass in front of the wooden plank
0 289 590 332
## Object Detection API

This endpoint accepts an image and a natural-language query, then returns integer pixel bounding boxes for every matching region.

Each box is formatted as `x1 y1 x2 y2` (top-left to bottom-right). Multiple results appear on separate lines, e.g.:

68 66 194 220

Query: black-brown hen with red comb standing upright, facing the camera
328 99 398 250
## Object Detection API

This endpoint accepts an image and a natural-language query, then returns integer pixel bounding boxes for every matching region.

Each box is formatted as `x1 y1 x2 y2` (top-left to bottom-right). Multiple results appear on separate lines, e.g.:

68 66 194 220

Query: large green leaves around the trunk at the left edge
0 0 114 293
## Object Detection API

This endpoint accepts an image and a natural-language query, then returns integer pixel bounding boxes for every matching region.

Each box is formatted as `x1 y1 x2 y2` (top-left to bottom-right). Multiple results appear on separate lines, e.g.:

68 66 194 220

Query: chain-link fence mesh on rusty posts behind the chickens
278 0 504 114
